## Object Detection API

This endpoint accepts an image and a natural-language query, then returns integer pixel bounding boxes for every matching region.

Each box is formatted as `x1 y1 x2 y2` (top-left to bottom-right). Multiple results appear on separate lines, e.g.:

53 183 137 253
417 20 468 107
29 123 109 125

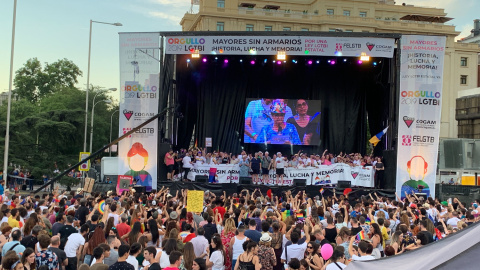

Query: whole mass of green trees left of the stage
0 58 118 186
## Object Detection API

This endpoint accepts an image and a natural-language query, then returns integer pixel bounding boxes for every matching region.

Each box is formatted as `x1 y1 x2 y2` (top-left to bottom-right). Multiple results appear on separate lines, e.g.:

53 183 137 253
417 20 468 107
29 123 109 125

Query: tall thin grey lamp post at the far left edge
3 0 17 190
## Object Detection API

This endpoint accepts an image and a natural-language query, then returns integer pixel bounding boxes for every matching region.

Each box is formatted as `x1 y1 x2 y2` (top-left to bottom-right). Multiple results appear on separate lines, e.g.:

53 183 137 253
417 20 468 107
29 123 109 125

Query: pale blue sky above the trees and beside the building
0 0 480 100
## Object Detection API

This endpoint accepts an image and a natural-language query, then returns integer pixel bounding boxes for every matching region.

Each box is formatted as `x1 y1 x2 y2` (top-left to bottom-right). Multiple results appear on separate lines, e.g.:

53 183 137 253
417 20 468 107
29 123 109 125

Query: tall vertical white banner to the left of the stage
118 33 160 191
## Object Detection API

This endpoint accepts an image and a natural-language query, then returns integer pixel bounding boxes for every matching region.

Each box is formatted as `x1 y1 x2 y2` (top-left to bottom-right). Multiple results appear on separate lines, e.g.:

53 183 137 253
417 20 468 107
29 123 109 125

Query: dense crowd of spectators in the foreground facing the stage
0 184 480 270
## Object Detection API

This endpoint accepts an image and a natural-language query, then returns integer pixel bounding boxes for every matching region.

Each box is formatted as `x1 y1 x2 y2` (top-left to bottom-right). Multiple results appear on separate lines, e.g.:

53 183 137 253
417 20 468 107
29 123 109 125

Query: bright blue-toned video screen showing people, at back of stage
244 98 320 145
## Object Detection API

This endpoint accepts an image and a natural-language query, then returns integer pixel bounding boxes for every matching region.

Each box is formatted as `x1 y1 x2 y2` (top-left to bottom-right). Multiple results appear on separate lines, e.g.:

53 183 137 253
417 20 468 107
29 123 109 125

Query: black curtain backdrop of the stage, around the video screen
172 55 390 154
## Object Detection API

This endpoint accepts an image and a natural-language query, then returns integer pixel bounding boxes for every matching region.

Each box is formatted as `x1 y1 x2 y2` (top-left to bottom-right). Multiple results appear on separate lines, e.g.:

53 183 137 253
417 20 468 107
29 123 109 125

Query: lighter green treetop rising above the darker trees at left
13 58 82 103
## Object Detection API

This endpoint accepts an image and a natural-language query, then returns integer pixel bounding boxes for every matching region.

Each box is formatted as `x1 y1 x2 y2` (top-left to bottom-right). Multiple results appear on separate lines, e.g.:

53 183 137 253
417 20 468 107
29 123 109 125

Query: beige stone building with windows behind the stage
180 0 479 138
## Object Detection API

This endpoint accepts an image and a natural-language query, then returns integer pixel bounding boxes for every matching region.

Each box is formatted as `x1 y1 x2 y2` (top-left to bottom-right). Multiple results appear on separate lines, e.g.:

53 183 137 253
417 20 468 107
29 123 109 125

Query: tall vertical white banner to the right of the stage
396 35 446 198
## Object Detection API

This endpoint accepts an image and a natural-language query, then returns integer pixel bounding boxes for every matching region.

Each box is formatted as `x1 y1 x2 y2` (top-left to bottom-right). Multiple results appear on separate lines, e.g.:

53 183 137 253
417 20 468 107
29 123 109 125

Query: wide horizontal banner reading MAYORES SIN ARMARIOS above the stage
165 36 395 58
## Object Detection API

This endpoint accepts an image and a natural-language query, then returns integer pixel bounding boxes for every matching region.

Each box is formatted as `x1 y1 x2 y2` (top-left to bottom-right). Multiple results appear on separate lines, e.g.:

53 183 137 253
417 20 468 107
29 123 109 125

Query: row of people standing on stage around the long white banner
165 148 385 188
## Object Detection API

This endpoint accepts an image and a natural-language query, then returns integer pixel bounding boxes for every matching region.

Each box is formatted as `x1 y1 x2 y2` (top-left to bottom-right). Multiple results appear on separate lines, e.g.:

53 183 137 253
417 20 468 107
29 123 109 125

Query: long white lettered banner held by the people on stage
187 163 375 187
